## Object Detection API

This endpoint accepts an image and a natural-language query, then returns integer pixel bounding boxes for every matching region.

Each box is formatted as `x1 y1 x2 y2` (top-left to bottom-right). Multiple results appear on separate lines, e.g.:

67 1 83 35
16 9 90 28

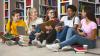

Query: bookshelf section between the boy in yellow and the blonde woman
16 0 33 21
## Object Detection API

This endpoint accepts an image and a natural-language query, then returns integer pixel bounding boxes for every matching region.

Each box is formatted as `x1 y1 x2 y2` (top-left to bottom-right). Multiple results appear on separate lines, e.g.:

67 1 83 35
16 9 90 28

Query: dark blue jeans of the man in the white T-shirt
56 26 69 42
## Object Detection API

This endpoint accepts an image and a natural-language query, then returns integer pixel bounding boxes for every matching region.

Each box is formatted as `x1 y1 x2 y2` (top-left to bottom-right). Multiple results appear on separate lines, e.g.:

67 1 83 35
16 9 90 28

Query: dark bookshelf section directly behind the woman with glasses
39 0 58 18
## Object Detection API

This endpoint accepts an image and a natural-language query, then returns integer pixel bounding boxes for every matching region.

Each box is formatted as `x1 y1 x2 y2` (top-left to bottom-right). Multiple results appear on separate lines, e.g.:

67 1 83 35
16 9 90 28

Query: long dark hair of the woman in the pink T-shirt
84 6 96 23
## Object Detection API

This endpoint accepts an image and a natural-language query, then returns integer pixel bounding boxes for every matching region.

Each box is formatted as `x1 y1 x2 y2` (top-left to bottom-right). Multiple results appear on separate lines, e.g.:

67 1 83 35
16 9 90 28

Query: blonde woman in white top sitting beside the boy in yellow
27 8 43 45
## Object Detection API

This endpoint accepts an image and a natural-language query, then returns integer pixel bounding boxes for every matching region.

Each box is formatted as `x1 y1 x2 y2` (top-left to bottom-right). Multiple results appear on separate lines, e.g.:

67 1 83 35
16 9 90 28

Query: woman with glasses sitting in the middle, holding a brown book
31 9 59 46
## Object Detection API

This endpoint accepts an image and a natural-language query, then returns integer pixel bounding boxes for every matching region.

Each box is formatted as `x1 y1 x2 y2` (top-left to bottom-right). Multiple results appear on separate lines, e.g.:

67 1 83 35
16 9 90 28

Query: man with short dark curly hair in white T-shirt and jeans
56 5 80 42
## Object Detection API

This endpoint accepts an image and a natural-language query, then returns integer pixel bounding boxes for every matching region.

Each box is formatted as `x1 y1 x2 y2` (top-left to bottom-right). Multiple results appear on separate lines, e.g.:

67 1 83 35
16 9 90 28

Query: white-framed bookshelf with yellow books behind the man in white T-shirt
58 0 78 19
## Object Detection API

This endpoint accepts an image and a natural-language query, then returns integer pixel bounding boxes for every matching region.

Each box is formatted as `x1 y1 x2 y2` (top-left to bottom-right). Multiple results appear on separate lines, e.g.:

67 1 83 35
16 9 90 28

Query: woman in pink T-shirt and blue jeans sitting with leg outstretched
47 7 97 51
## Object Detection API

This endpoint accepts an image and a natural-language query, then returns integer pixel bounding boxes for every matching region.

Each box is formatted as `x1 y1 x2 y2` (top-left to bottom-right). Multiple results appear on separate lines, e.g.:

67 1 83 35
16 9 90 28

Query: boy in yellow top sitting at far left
6 10 27 44
